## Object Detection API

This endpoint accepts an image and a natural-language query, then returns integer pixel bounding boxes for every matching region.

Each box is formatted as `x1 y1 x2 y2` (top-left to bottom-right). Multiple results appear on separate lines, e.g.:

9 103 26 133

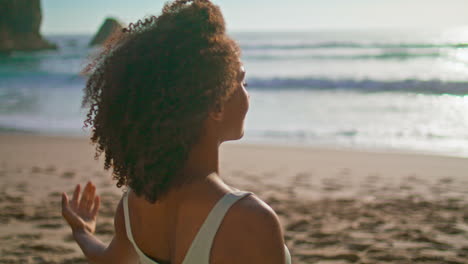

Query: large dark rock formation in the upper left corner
0 0 57 53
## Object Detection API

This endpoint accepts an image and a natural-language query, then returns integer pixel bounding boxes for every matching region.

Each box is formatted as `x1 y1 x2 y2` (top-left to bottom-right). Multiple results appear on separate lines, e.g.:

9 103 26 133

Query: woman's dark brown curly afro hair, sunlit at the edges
82 0 241 203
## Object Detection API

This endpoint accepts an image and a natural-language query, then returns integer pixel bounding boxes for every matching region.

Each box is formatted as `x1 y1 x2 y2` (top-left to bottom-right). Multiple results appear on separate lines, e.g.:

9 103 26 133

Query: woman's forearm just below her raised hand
73 229 109 264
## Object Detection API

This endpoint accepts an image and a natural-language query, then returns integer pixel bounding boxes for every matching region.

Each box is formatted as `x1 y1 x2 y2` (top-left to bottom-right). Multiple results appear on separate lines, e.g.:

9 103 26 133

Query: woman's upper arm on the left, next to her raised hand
101 199 138 263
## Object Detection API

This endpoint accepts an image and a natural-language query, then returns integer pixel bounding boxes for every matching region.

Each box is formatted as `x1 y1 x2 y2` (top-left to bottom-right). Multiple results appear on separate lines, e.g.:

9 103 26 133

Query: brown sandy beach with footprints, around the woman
0 134 468 264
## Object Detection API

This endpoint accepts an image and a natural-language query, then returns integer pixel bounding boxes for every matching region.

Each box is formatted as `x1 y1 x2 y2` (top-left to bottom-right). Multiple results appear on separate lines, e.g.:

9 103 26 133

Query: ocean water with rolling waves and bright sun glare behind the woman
0 28 468 157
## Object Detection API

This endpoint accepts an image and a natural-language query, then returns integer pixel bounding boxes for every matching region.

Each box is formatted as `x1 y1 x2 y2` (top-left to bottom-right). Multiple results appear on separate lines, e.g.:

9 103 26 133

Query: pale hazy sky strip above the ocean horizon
41 0 468 34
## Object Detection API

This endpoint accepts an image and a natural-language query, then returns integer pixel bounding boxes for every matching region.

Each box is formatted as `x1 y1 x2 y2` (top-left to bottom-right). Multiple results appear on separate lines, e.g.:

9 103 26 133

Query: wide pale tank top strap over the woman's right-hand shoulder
182 189 252 264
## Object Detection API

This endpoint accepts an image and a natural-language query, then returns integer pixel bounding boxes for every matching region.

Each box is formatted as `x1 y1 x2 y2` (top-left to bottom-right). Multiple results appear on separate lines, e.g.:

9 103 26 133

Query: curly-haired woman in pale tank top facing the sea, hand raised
62 0 290 264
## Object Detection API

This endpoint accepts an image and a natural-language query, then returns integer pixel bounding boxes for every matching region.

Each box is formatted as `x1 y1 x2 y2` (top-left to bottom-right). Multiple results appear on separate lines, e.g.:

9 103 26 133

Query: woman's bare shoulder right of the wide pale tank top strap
211 195 285 264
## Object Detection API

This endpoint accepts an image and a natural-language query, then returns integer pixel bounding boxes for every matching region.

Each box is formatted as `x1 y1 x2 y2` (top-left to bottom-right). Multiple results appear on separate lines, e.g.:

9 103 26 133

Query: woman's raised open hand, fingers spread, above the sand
62 182 101 233
